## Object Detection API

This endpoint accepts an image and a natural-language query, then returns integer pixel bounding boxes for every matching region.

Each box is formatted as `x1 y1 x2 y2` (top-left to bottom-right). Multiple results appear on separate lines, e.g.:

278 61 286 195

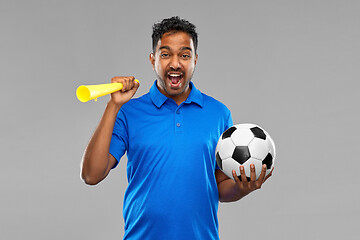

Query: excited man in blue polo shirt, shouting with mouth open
82 17 272 240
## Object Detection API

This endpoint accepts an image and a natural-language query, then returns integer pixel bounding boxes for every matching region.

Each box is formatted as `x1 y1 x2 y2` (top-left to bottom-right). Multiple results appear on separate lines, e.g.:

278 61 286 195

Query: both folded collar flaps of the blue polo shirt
150 80 203 108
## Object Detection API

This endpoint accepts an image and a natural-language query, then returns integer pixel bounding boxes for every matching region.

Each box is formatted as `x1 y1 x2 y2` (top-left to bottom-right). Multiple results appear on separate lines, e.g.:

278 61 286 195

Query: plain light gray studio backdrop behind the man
0 0 360 240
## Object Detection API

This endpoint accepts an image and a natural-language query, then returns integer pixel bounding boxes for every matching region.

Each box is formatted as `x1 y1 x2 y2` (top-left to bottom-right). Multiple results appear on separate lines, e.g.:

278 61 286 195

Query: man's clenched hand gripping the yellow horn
110 76 140 107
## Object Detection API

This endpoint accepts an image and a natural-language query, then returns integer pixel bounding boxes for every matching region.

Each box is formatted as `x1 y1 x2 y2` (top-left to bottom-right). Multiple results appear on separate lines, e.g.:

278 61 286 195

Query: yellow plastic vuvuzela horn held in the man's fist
76 79 139 102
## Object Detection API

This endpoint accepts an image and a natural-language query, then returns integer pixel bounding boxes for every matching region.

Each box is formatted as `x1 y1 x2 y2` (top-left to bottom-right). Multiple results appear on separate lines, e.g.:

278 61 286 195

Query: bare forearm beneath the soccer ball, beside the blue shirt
218 178 249 202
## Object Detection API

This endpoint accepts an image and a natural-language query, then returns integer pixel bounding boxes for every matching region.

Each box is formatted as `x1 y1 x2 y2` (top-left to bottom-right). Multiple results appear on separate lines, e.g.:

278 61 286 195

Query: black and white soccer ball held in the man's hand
215 123 276 181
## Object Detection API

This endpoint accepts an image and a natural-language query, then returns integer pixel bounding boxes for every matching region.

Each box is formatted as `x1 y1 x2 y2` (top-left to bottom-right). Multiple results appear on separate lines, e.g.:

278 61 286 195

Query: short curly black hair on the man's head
152 16 198 53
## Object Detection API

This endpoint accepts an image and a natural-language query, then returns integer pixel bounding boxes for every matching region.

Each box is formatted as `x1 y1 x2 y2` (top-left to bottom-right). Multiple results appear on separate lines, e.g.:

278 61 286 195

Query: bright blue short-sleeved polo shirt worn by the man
110 81 233 240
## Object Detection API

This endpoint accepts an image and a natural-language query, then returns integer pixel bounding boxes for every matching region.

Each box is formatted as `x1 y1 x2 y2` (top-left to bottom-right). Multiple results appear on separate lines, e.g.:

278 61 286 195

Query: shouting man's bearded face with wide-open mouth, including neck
150 32 197 104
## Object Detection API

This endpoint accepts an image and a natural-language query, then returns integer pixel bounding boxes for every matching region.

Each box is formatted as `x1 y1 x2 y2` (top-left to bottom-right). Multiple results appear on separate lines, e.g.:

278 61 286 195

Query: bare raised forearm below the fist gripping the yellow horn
81 102 120 185
